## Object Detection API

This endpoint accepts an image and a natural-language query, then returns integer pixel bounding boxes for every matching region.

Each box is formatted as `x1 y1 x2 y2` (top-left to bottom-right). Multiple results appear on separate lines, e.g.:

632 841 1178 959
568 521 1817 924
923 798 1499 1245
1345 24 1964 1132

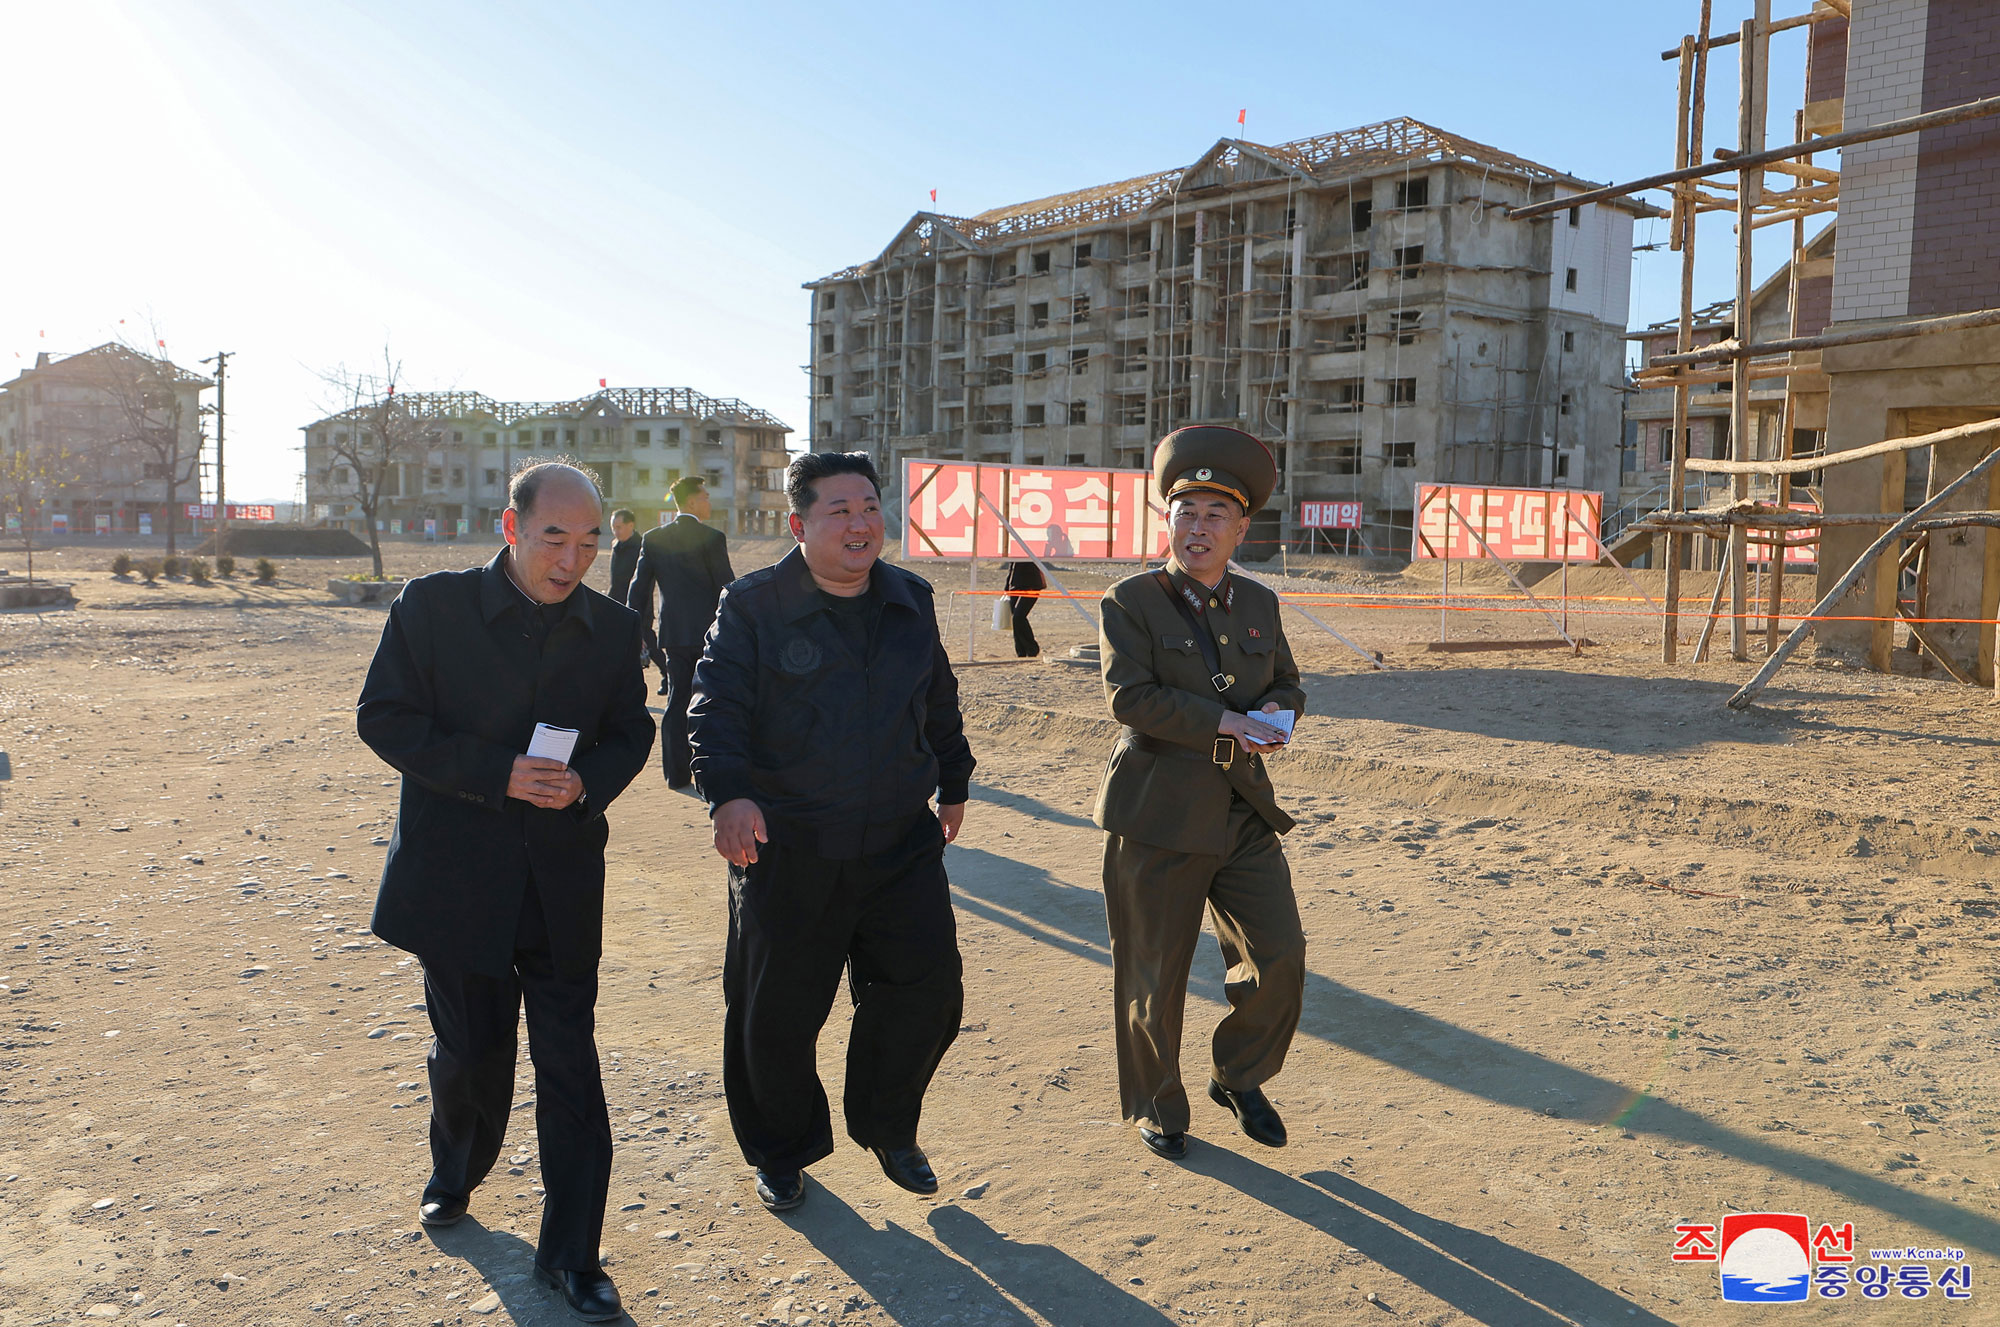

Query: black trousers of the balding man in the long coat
424 883 612 1271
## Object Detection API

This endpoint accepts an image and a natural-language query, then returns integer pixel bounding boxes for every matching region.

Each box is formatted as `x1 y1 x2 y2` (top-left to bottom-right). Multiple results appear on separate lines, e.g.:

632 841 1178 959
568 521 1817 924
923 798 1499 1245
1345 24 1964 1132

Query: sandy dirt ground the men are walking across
0 542 2000 1327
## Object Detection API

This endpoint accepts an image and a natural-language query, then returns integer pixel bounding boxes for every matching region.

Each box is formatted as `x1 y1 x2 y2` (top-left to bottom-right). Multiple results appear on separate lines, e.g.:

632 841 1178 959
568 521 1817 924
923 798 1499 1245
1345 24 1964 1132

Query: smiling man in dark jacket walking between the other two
688 452 974 1211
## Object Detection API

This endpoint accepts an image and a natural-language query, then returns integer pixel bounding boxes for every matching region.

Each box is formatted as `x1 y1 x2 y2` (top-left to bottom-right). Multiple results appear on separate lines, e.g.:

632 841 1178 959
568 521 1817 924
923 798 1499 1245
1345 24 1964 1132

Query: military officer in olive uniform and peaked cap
1096 426 1306 1161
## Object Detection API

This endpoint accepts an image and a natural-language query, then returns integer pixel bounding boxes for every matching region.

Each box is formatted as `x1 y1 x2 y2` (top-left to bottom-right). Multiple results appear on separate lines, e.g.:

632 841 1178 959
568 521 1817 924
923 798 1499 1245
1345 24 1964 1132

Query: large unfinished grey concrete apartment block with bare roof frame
806 120 1660 552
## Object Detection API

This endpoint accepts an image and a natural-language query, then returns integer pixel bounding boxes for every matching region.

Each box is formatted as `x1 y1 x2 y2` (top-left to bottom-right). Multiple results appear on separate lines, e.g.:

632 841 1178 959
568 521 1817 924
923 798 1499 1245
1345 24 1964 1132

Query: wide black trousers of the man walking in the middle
722 813 966 1171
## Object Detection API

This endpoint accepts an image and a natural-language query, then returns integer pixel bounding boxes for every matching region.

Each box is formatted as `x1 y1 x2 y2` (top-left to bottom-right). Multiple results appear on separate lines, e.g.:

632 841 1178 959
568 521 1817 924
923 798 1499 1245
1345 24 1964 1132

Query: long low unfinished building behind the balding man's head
304 388 792 534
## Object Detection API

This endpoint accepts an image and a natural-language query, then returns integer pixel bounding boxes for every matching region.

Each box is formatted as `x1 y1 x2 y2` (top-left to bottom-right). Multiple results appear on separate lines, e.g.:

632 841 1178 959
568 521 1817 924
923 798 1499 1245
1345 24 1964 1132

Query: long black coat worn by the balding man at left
356 550 654 975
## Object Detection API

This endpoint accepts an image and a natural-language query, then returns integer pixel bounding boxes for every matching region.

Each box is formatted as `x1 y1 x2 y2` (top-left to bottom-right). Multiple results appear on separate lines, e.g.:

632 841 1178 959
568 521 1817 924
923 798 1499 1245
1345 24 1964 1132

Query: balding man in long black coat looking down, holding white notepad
356 464 652 1321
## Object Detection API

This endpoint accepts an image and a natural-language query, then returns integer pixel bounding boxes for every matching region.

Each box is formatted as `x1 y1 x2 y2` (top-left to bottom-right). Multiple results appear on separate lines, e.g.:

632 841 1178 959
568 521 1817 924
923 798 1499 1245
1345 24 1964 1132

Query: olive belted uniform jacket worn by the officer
1094 572 1306 857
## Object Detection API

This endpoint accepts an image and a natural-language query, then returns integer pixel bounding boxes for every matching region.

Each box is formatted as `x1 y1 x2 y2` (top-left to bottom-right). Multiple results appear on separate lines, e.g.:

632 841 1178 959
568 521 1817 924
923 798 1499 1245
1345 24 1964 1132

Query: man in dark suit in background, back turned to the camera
626 474 736 787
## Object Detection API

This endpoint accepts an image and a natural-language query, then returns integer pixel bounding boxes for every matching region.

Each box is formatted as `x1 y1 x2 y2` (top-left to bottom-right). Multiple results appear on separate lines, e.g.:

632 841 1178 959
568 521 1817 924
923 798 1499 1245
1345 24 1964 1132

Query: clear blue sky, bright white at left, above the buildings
0 0 1806 500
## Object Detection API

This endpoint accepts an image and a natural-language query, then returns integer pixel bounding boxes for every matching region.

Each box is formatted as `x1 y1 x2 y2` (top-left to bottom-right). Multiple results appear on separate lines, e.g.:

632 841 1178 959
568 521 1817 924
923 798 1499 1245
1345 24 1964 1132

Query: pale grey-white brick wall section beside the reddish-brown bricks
1834 0 1930 322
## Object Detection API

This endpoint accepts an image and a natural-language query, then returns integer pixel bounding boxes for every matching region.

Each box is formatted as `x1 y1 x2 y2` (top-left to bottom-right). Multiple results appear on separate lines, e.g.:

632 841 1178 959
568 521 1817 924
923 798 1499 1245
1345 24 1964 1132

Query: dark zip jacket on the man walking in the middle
688 548 974 855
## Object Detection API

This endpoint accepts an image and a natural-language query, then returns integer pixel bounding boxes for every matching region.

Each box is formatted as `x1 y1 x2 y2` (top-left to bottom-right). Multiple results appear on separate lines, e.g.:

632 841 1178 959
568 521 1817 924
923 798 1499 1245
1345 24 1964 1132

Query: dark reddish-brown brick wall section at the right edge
1896 0 2000 318
